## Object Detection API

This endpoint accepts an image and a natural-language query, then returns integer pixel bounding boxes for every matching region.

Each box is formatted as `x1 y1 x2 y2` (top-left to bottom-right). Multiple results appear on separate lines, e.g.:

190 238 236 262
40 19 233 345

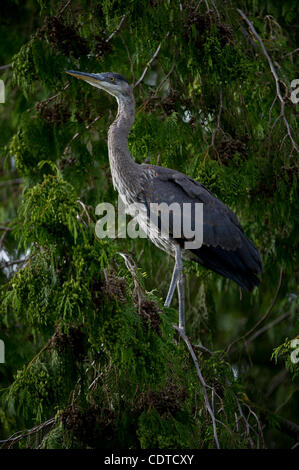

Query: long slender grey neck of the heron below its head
108 93 138 193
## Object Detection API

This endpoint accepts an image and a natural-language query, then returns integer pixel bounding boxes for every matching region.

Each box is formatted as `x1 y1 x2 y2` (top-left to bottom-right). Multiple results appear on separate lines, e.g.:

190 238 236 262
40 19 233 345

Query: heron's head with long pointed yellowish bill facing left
66 70 132 99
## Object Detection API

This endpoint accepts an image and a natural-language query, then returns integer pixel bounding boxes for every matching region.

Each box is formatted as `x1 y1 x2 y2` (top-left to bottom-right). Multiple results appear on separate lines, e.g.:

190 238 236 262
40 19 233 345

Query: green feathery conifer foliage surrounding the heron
0 0 299 449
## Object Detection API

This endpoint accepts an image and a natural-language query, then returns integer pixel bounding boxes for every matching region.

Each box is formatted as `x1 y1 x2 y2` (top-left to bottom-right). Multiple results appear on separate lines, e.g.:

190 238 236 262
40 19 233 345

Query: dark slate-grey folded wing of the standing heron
140 165 262 290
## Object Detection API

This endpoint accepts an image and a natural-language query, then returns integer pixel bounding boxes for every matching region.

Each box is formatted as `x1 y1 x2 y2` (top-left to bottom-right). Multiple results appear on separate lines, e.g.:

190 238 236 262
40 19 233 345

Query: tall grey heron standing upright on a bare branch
67 70 262 332
